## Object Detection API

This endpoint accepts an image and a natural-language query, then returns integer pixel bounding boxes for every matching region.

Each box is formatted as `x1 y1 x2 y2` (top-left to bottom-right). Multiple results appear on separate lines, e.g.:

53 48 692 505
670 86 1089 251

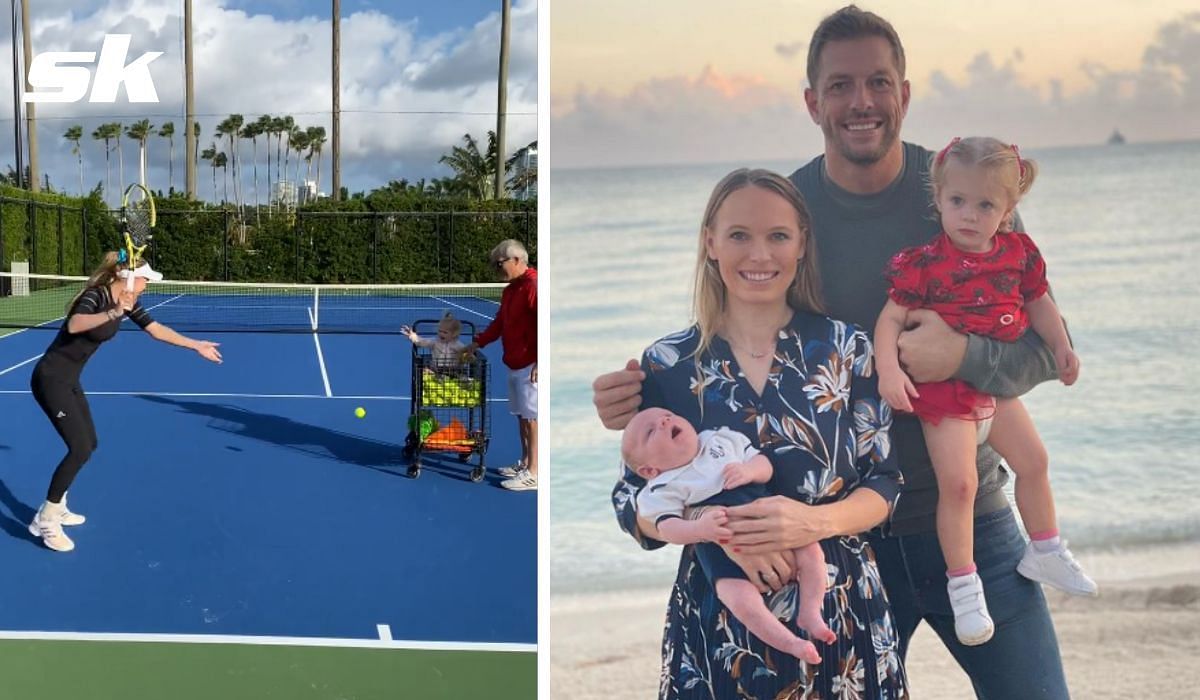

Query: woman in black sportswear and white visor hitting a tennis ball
29 251 221 552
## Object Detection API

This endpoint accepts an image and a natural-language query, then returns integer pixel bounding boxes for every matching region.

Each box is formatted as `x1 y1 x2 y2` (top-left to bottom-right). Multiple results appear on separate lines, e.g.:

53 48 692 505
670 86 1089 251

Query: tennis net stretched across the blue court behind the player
0 273 505 334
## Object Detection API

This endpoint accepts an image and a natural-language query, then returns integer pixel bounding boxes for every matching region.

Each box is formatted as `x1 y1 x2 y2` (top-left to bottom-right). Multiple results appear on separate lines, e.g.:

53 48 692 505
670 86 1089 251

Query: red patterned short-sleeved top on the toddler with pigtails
884 232 1046 342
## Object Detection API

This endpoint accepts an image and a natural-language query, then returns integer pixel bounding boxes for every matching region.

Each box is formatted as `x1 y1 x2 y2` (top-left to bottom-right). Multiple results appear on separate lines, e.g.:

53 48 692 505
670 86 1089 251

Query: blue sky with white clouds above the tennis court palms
0 0 538 198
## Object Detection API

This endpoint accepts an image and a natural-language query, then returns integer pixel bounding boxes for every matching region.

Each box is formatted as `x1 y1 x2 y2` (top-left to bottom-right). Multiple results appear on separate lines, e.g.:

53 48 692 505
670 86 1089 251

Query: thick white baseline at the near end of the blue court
0 630 538 652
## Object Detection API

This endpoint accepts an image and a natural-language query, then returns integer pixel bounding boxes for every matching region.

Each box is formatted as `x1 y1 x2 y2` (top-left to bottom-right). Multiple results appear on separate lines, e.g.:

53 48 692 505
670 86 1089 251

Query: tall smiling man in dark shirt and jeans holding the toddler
594 5 1068 700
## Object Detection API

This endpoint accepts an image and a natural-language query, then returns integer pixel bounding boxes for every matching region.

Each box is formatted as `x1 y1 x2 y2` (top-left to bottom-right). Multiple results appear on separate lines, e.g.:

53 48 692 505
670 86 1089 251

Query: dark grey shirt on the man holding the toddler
791 143 1055 534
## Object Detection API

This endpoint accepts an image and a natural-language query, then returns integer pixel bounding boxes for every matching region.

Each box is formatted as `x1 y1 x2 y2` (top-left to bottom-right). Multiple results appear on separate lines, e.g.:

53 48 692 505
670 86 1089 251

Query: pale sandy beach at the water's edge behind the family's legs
550 561 1200 700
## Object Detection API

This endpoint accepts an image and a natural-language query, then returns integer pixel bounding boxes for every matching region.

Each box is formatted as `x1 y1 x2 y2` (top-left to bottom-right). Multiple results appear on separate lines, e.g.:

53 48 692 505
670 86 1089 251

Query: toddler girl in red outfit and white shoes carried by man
875 137 1097 645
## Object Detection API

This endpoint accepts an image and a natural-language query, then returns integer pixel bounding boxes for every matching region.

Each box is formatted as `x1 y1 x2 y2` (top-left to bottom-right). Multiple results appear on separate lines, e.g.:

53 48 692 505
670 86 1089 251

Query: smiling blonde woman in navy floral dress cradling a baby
610 169 907 699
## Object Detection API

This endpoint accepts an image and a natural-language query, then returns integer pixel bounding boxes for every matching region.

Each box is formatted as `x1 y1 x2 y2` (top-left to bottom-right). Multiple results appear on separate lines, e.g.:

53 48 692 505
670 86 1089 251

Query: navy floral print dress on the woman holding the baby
613 312 908 700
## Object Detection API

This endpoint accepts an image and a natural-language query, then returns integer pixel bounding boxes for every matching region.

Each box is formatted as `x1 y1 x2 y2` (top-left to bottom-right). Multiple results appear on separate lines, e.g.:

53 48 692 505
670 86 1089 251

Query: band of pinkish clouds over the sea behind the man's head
550 13 1200 167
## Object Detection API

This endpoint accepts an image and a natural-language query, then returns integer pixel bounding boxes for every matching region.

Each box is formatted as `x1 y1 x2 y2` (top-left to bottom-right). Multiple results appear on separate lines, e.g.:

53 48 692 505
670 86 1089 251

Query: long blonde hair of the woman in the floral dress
692 168 824 357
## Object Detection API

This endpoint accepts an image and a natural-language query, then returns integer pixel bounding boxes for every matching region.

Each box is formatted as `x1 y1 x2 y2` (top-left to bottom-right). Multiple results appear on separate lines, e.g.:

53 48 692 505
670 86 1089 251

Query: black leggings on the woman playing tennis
30 371 100 503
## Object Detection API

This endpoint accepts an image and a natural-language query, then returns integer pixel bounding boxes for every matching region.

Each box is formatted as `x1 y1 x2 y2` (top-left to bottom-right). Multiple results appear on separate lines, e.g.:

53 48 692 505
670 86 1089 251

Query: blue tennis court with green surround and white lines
0 272 536 698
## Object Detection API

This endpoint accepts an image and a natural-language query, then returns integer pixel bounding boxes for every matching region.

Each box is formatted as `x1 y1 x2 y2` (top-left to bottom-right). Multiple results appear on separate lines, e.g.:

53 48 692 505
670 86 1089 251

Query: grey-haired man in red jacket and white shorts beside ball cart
467 239 538 491
